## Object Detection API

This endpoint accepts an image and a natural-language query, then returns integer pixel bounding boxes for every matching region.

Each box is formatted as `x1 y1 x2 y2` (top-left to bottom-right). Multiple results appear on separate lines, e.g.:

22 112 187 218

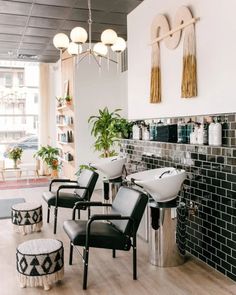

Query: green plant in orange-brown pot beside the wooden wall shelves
34 145 62 178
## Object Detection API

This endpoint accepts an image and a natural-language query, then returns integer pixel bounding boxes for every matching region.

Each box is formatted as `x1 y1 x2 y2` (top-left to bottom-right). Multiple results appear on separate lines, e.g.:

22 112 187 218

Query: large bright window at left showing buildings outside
0 61 39 157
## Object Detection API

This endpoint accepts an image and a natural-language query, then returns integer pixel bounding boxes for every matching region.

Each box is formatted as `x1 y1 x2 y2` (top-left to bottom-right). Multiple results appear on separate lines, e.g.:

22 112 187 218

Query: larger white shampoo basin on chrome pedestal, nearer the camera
126 167 186 202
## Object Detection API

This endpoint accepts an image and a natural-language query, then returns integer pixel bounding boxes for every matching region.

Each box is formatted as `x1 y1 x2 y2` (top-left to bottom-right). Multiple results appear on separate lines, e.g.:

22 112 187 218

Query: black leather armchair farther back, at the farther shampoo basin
43 169 98 234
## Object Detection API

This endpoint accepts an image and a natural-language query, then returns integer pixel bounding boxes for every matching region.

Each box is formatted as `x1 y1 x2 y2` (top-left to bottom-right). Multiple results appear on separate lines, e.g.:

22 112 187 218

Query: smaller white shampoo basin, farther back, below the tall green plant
90 157 126 179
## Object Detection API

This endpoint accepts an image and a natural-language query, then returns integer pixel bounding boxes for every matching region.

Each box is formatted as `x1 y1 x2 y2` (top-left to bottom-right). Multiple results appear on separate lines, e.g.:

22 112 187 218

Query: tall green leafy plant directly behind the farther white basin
88 107 121 158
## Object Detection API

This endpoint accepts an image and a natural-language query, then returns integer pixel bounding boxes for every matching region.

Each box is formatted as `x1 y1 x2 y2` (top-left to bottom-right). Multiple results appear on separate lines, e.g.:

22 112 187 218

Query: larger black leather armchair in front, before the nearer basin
63 187 148 289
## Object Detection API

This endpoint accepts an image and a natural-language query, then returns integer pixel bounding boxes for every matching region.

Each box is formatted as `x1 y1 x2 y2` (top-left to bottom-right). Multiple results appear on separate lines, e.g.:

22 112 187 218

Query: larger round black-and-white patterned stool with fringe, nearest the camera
16 239 64 290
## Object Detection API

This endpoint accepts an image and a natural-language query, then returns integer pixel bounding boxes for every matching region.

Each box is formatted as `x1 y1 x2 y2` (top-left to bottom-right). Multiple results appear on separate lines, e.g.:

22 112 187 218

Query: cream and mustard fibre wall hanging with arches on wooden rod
150 6 199 103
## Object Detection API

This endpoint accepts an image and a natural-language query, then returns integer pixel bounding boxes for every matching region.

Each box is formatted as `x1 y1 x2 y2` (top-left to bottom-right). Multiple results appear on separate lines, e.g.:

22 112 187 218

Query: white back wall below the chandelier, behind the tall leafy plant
75 58 127 165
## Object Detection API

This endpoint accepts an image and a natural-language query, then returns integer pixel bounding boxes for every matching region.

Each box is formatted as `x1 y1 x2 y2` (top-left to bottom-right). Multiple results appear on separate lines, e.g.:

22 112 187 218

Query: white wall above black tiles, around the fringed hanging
128 0 236 119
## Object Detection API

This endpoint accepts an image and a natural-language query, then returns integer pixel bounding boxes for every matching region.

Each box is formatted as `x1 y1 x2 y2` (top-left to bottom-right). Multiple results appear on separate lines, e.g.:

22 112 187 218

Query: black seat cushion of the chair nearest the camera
63 220 131 251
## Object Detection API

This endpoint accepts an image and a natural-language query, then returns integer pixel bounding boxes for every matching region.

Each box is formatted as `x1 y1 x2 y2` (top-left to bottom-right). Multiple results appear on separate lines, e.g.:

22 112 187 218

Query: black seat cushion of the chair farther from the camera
43 192 83 208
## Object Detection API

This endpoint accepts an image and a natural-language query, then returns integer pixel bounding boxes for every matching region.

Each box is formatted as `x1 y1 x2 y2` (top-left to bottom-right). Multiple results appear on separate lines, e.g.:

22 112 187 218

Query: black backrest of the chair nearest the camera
111 186 148 236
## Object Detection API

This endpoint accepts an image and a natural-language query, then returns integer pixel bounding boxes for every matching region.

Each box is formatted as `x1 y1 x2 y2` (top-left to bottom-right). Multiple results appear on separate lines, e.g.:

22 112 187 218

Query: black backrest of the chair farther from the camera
75 169 98 201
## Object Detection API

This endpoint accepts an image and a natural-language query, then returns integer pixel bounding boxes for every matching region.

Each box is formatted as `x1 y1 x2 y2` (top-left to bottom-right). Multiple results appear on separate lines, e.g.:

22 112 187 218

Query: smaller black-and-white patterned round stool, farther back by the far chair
11 203 43 235
